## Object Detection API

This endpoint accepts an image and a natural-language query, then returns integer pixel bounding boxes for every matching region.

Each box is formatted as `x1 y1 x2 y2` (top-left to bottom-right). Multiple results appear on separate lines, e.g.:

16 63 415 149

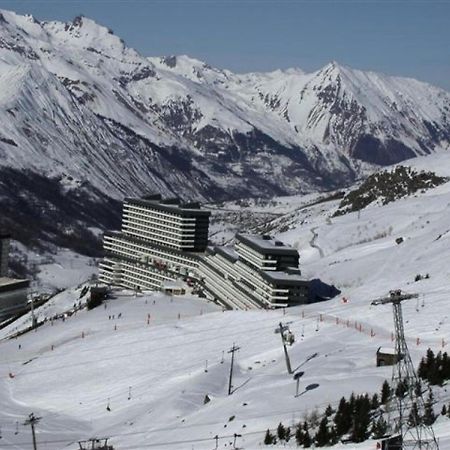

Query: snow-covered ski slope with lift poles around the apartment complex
0 155 450 450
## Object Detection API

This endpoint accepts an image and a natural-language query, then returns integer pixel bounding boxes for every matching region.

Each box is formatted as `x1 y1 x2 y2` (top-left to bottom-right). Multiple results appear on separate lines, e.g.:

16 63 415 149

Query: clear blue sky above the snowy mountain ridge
0 0 450 90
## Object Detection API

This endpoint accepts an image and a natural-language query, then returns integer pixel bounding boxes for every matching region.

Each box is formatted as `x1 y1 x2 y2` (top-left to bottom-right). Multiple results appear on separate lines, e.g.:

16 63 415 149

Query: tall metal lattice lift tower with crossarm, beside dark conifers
372 290 439 450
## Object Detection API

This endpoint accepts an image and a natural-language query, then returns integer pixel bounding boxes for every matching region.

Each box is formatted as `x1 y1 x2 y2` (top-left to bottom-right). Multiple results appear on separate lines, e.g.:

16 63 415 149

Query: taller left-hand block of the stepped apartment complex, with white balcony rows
99 195 210 290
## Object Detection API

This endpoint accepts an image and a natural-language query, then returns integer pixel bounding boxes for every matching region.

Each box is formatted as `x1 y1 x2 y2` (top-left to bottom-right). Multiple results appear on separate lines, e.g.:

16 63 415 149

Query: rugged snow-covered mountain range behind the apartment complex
0 11 450 256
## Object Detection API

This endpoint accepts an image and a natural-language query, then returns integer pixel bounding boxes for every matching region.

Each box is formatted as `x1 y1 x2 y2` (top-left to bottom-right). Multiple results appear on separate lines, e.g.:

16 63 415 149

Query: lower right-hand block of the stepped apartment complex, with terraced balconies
199 234 309 309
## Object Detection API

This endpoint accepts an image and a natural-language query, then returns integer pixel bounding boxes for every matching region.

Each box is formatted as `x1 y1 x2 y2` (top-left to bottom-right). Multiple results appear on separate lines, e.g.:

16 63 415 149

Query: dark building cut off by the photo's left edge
0 231 30 323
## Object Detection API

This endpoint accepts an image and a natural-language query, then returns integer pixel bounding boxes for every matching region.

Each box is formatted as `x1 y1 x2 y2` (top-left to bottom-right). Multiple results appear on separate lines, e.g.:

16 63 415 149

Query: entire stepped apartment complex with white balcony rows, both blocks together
99 195 308 309
